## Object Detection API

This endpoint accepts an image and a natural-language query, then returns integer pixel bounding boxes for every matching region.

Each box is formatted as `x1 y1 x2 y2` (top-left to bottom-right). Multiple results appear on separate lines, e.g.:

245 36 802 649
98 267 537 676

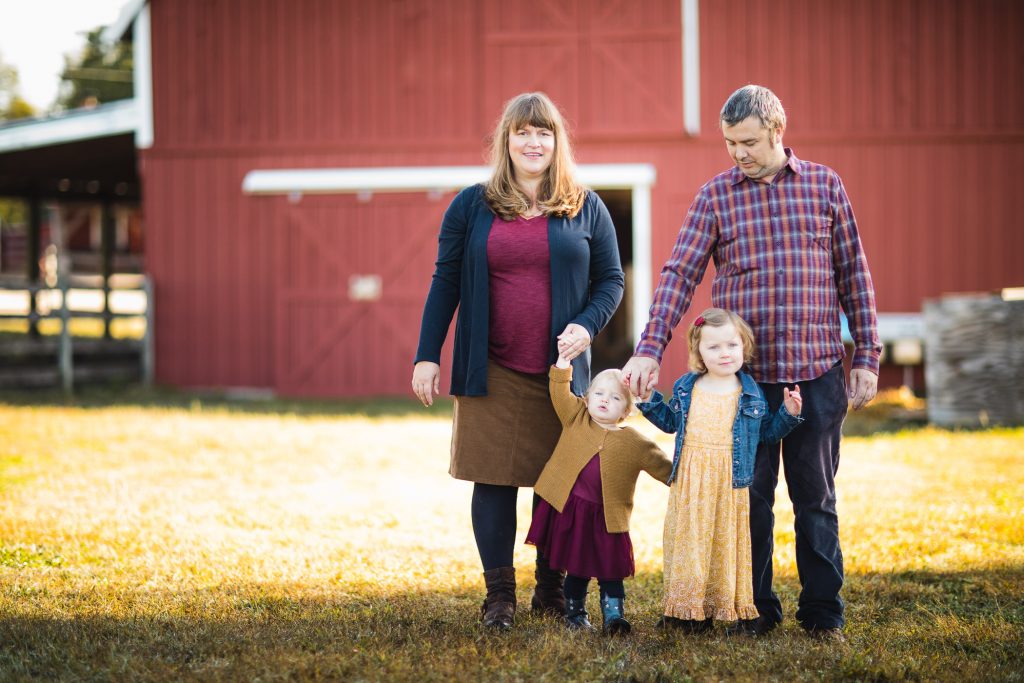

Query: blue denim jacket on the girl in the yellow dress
638 372 804 488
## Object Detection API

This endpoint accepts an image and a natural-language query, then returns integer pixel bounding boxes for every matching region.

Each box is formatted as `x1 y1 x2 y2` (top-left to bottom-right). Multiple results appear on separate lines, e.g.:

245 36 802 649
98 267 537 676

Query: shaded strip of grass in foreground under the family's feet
0 567 1024 681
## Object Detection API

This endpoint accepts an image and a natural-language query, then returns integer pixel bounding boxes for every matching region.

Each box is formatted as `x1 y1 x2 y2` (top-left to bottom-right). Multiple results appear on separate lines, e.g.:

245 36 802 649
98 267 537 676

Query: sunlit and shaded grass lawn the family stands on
0 400 1024 681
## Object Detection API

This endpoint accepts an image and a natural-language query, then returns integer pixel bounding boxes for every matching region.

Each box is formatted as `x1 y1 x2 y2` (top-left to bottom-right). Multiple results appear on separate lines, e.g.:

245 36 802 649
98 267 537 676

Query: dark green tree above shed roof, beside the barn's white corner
56 27 133 109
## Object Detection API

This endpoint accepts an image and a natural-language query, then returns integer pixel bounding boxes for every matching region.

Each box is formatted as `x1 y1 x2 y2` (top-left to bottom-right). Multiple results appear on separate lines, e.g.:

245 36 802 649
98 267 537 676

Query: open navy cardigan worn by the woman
415 184 625 396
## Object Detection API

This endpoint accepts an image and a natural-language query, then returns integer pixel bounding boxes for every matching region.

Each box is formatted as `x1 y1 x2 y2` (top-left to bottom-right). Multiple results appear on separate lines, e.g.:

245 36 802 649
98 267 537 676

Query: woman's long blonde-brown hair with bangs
484 92 587 220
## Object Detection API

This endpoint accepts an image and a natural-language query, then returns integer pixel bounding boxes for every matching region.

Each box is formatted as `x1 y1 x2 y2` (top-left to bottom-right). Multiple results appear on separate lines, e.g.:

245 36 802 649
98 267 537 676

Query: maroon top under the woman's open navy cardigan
487 215 551 373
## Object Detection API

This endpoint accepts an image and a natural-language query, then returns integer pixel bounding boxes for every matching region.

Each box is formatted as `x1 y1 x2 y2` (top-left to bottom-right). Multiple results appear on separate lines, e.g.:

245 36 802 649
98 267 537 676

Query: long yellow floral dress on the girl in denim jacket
664 386 758 622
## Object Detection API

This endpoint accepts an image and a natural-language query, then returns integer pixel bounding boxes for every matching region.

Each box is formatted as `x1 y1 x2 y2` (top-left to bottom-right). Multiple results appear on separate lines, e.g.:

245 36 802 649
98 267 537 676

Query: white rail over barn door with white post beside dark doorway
242 164 657 345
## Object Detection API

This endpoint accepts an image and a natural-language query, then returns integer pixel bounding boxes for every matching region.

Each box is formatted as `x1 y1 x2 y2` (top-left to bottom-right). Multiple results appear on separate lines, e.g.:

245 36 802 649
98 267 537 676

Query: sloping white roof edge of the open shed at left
0 99 139 153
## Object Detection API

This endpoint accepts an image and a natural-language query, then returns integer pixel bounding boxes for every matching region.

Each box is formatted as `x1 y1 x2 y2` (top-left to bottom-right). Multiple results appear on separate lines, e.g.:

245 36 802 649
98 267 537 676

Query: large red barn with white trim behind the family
2 0 1024 396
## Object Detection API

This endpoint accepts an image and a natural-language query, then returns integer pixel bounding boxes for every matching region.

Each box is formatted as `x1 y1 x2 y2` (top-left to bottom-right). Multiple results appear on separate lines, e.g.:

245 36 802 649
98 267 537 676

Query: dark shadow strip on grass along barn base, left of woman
0 385 453 418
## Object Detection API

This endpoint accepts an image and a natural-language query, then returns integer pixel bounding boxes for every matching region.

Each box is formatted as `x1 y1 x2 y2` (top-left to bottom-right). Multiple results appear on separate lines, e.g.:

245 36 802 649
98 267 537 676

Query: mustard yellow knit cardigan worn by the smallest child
534 366 672 533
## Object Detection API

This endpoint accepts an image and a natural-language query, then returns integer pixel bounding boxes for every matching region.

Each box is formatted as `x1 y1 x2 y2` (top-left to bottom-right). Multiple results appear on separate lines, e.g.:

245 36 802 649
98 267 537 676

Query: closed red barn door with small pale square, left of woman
274 194 451 396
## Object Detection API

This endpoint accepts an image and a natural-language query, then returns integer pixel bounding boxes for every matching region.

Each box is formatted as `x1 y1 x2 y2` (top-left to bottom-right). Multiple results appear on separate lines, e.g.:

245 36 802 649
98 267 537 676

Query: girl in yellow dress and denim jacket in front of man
639 308 803 635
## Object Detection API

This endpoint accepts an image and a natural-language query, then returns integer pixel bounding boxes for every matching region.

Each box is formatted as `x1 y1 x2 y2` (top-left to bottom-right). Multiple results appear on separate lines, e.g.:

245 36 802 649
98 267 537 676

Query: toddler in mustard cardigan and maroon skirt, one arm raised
526 344 672 634
